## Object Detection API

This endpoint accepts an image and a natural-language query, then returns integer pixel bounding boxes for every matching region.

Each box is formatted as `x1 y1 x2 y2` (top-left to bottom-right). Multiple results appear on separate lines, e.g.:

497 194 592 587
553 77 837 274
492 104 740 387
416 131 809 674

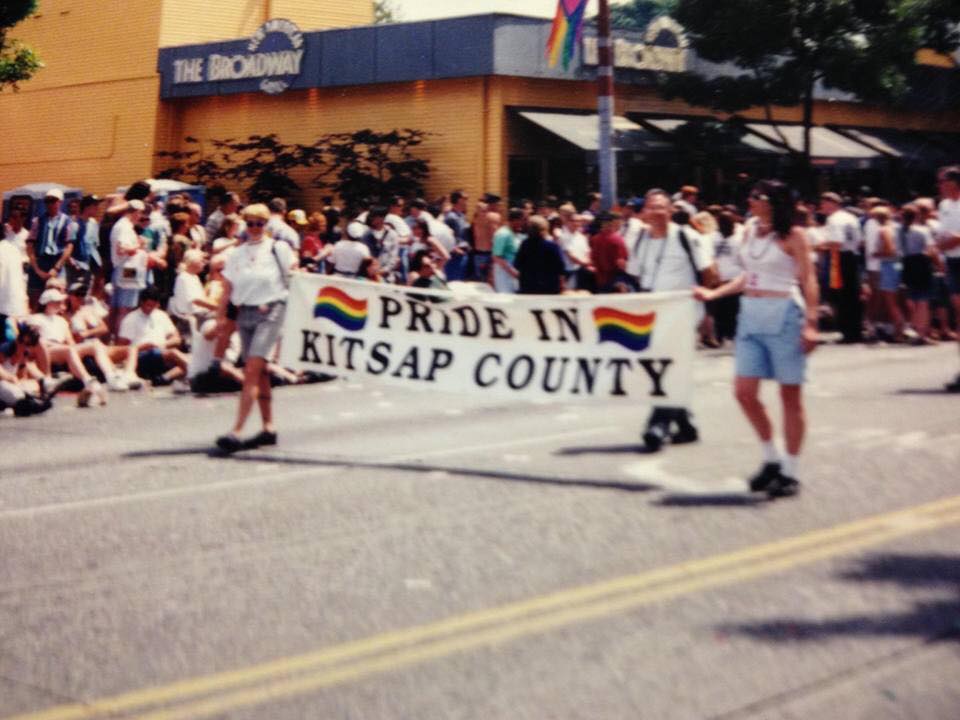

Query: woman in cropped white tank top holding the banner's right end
694 180 819 497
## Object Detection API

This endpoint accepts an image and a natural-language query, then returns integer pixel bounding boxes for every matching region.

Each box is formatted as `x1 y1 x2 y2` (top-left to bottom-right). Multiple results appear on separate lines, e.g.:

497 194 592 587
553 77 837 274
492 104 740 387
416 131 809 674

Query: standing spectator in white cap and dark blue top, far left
27 188 77 308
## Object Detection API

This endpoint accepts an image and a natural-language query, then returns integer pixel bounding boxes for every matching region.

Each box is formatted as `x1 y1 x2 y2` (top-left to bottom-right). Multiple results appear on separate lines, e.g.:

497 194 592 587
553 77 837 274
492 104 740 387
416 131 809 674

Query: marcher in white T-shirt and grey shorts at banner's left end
217 204 296 453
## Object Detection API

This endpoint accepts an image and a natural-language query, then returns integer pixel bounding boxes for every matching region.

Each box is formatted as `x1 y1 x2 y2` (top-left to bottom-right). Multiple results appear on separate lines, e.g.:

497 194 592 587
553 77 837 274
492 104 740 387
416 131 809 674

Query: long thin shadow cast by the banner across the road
123 447 659 492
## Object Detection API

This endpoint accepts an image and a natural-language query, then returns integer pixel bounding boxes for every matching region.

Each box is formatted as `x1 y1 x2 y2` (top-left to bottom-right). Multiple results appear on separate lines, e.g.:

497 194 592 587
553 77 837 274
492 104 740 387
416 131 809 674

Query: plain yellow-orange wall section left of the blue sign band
0 0 161 193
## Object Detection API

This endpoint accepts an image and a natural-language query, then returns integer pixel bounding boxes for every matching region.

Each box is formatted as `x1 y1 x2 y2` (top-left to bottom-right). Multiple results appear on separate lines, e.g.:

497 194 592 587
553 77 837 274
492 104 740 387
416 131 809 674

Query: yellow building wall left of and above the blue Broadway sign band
0 0 373 193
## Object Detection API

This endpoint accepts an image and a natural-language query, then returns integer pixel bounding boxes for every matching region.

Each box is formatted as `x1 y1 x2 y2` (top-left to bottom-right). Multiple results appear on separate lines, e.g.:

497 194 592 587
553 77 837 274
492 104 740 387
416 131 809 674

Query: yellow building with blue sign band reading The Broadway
0 0 960 206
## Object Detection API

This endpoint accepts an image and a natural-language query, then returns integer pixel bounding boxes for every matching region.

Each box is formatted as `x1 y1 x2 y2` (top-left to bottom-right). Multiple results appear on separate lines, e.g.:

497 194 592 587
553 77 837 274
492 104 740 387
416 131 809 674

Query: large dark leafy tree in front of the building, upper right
660 0 960 169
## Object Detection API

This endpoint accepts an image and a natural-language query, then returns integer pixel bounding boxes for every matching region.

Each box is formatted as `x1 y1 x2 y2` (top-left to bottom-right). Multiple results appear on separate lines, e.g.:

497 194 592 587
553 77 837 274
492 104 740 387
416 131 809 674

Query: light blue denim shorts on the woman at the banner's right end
735 296 807 385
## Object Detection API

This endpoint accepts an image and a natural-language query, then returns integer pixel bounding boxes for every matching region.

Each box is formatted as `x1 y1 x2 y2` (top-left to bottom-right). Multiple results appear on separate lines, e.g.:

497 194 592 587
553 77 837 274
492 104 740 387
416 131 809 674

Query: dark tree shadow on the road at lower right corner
721 555 960 642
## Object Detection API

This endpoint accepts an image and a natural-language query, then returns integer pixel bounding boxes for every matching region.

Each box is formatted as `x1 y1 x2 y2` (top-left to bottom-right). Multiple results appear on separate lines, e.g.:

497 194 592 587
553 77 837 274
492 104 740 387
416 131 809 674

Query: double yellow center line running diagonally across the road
8 496 960 720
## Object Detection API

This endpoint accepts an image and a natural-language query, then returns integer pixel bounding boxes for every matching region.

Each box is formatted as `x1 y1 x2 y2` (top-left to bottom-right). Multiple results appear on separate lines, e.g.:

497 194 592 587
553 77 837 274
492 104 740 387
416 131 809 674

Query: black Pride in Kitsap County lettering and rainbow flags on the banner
299 290 673 397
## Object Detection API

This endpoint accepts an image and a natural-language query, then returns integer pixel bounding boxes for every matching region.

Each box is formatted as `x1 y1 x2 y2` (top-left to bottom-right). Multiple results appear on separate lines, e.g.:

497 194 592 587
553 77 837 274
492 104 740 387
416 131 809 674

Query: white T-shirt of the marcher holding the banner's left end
223 238 296 306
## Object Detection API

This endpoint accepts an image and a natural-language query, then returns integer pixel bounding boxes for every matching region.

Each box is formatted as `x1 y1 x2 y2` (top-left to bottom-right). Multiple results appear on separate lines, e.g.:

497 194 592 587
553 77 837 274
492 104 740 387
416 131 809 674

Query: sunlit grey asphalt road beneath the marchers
0 346 960 720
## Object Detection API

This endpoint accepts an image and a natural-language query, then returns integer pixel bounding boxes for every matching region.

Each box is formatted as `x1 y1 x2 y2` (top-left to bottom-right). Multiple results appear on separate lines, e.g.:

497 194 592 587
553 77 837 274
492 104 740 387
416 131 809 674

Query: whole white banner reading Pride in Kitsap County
281 273 695 406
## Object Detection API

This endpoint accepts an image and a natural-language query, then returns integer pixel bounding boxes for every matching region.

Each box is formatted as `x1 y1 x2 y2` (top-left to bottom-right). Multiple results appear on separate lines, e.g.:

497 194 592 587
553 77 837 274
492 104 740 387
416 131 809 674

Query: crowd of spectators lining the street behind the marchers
0 167 960 415
